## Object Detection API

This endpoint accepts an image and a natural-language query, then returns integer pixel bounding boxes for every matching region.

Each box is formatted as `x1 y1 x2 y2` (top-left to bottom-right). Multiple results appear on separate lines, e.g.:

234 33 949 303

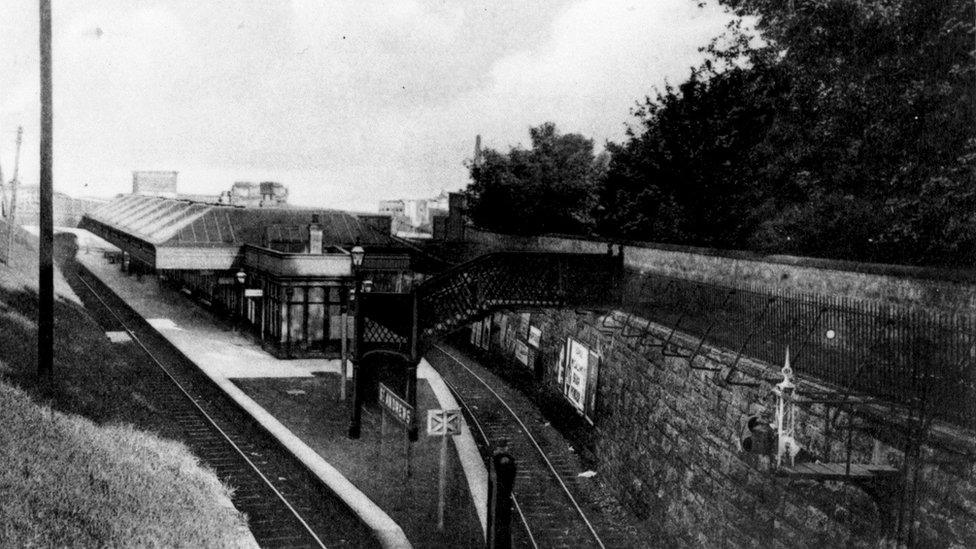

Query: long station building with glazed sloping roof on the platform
81 195 423 358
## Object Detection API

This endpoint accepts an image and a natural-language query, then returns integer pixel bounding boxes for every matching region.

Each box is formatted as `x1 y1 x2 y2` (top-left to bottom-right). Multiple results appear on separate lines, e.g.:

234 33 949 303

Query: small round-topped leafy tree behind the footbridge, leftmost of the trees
466 122 606 234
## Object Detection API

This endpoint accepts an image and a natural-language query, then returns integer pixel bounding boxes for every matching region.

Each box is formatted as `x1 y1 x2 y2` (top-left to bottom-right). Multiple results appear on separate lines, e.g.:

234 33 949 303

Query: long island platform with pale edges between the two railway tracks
77 253 487 547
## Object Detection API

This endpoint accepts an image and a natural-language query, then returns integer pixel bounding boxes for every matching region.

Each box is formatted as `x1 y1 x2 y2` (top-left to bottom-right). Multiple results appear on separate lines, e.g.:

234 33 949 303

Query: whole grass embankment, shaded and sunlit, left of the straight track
0 226 252 547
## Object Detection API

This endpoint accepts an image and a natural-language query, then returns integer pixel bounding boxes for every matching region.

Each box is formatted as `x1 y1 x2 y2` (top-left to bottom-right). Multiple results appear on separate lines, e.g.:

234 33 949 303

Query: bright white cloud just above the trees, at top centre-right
469 0 730 148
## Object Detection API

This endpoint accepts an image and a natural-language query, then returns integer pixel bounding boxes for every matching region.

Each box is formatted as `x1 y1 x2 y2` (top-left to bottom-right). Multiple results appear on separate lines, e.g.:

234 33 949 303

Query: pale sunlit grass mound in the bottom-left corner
0 385 243 547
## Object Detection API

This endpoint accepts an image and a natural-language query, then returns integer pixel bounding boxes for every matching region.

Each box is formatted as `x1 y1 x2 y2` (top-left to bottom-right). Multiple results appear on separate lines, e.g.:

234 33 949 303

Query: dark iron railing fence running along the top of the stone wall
622 274 976 427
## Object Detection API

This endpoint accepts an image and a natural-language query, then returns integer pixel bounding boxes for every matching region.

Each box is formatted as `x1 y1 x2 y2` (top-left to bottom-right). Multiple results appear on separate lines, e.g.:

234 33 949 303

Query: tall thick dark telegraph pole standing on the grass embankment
37 0 54 377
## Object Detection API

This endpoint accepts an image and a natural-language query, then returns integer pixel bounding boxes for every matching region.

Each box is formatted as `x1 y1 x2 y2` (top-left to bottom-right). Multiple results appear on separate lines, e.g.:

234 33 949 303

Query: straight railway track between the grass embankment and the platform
66 263 379 548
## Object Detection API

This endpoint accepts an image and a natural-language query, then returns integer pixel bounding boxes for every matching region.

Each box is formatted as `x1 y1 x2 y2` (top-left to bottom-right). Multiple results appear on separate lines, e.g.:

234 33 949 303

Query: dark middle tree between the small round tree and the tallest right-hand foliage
598 61 769 247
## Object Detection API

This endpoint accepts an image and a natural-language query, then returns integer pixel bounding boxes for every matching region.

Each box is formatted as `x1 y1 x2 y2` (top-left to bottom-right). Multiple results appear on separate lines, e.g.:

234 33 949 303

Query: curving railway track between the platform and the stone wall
428 345 616 549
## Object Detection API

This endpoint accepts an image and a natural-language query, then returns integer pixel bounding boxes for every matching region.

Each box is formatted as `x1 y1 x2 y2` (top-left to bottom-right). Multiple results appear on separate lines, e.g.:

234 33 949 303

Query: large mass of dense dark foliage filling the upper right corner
472 0 976 266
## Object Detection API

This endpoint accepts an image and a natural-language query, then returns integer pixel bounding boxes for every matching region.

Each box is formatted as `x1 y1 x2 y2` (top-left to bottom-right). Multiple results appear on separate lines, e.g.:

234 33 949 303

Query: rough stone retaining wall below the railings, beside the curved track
478 310 976 547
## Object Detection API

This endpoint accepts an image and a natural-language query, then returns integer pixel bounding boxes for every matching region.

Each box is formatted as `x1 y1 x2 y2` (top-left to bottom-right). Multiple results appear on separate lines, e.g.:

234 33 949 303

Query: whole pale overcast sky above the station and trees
0 0 729 210
